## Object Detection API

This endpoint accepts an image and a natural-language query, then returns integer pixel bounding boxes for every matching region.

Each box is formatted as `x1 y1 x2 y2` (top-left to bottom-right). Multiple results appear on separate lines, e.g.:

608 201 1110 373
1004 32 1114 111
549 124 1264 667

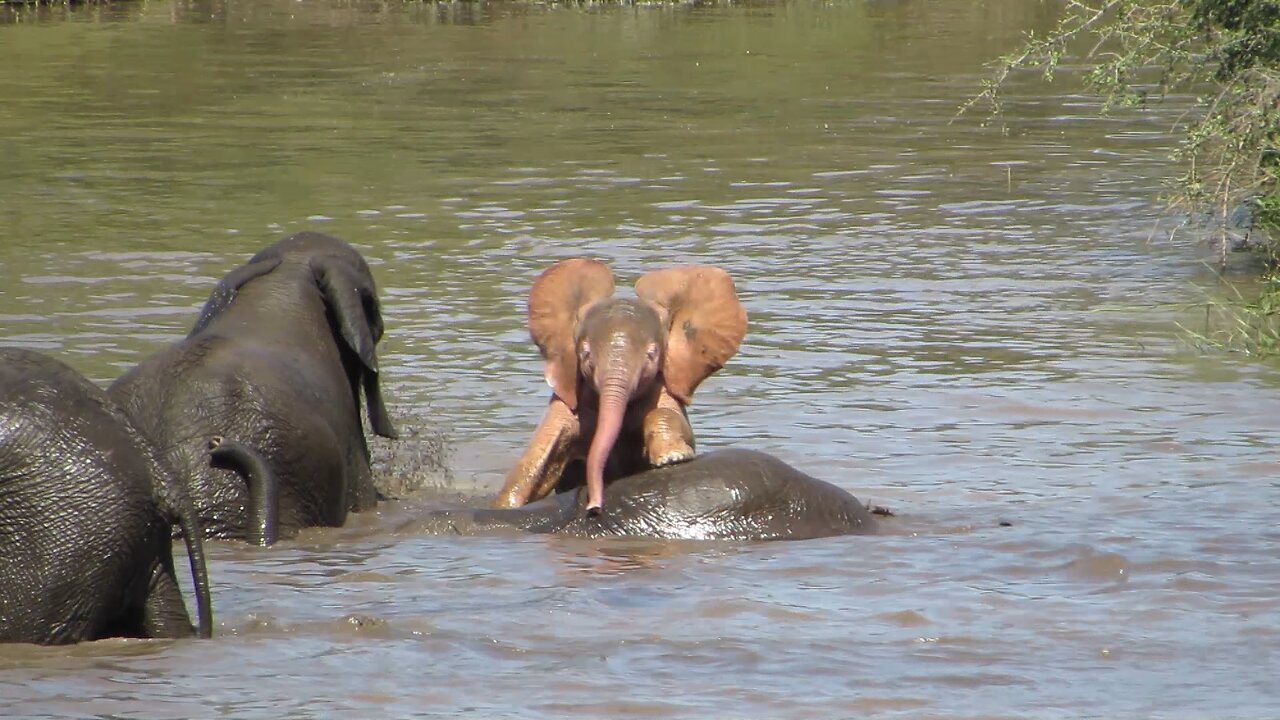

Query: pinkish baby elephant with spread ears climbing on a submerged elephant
493 258 746 512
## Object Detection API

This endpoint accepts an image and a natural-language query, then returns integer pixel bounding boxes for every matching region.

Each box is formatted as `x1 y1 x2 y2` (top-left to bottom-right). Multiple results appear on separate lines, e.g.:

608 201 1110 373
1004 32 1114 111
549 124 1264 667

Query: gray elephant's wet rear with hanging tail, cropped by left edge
0 348 212 644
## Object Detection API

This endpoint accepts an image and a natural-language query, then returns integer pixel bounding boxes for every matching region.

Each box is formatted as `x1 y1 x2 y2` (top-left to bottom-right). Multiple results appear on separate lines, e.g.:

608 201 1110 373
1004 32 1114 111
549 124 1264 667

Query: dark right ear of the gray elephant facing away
311 258 399 438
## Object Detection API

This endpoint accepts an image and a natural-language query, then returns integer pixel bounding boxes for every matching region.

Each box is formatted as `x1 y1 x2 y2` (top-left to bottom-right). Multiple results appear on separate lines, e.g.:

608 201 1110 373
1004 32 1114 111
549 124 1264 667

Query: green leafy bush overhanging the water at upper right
975 0 1280 355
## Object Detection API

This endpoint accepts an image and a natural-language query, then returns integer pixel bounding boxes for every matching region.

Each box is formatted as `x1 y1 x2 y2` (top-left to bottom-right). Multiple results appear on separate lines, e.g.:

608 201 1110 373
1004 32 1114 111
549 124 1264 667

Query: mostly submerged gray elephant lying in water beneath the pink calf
401 448 877 541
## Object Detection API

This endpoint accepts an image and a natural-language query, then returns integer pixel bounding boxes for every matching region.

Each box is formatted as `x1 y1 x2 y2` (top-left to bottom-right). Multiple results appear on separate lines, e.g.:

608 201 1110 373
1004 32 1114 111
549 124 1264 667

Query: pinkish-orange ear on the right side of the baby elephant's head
636 265 746 405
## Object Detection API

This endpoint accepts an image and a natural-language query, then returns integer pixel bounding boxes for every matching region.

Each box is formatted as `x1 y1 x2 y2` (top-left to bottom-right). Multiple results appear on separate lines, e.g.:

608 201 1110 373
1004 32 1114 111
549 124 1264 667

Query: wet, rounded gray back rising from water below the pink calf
558 450 876 541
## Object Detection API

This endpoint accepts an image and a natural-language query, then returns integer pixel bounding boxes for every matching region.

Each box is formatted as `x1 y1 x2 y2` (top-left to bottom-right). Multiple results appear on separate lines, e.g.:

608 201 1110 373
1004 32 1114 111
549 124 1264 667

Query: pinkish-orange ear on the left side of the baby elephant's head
529 258 613 410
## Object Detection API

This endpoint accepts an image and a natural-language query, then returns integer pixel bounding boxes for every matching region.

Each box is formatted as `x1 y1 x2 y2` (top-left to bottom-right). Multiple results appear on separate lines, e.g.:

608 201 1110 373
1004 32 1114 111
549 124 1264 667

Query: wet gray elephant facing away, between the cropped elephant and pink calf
109 232 396 544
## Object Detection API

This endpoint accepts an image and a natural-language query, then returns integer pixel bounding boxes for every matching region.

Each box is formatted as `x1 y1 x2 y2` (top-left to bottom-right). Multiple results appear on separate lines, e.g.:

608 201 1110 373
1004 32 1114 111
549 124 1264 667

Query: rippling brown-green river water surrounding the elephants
0 0 1280 719
